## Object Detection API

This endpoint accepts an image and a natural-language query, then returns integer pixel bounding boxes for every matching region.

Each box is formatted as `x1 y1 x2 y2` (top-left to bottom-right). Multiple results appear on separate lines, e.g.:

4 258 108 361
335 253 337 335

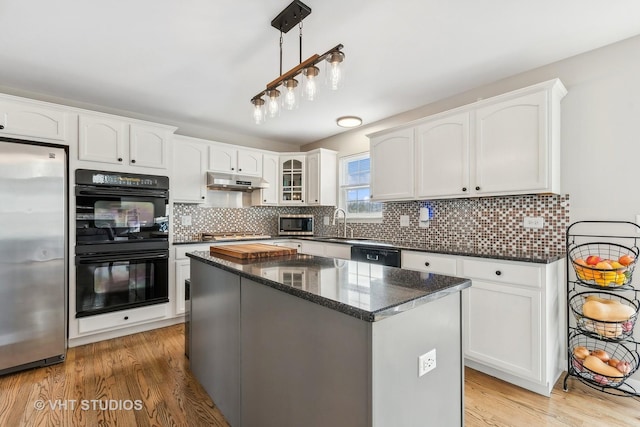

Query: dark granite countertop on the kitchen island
187 251 471 322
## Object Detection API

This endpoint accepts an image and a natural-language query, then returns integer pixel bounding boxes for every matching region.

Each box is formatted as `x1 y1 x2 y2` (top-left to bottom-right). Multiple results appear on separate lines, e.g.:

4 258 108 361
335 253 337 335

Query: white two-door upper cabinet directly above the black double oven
78 114 175 169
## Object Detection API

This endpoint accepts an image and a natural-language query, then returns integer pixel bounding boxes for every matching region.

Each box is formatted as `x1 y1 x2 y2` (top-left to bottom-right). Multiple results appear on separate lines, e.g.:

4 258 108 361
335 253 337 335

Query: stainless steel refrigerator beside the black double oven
0 138 68 375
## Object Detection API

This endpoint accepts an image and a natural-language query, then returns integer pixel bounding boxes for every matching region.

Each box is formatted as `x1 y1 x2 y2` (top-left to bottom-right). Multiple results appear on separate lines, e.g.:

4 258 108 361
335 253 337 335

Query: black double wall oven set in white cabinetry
75 169 169 317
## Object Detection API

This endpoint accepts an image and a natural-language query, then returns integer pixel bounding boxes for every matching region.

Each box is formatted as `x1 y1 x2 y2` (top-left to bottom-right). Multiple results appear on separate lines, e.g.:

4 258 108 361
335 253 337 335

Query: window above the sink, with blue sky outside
340 153 382 219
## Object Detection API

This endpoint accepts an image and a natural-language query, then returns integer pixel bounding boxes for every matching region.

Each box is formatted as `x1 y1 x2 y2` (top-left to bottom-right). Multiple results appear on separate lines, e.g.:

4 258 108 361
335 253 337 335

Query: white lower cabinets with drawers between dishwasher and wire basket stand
402 251 565 396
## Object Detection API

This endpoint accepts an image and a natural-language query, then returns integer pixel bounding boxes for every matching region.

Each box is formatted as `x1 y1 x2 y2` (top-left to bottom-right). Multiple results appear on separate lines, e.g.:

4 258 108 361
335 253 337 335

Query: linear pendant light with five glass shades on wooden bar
251 0 344 124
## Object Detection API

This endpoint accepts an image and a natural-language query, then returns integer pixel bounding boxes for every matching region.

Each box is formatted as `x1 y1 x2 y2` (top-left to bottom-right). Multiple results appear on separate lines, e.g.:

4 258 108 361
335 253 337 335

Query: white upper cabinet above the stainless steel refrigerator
0 95 70 143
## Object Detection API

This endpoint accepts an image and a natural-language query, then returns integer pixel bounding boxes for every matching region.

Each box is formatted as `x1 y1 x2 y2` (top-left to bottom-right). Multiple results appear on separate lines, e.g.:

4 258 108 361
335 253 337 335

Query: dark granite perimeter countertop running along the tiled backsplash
173 236 566 264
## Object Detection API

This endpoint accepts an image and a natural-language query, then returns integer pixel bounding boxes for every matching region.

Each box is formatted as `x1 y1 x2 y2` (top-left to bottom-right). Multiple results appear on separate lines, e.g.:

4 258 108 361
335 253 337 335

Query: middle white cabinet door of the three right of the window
415 112 470 198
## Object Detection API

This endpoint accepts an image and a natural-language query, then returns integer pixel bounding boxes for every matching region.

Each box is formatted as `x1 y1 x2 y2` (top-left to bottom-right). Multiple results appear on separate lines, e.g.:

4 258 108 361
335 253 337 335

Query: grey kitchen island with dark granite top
188 252 471 427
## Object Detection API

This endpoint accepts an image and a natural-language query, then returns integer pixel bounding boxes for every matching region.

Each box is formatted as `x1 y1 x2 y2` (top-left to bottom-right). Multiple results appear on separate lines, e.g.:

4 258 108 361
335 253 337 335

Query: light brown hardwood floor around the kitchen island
0 325 640 427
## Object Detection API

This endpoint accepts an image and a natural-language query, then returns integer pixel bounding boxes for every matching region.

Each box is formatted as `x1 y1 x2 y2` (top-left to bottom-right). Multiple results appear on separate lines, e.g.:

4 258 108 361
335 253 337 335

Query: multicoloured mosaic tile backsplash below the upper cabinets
172 195 570 252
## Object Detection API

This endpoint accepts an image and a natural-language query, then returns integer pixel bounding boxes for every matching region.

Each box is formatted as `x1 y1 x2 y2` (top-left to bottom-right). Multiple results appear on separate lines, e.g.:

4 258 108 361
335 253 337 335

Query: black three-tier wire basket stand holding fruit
563 221 640 400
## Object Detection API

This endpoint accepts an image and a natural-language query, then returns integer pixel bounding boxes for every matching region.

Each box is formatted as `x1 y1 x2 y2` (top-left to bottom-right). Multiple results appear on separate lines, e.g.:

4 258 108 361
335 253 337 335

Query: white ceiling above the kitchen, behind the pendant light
0 0 640 144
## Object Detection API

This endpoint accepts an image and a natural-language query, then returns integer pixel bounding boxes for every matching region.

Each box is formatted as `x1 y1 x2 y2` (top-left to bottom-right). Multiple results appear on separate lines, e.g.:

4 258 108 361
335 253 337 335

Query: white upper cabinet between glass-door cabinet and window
307 149 338 206
